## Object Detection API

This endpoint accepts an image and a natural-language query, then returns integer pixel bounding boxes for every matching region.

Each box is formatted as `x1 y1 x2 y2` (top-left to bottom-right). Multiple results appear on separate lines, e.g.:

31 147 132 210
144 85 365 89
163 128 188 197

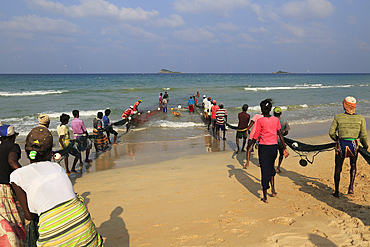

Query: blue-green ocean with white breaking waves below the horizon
0 74 370 143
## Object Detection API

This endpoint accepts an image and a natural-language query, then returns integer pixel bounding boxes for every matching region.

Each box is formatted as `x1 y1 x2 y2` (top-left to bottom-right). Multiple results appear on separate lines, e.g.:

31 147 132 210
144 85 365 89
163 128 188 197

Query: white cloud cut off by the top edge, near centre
173 0 250 15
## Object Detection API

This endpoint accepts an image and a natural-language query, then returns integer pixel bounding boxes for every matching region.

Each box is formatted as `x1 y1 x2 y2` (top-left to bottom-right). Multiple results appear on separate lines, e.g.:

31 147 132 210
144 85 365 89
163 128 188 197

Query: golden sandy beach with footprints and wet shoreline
46 126 370 246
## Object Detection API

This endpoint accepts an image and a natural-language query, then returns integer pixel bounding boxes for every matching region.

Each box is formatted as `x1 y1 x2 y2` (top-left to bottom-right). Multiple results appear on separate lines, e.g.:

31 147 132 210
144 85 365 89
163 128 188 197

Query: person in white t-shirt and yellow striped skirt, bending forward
10 126 103 246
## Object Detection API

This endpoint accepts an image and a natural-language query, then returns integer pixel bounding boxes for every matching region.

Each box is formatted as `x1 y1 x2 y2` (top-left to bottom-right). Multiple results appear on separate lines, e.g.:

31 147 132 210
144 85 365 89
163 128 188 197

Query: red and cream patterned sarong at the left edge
0 184 26 246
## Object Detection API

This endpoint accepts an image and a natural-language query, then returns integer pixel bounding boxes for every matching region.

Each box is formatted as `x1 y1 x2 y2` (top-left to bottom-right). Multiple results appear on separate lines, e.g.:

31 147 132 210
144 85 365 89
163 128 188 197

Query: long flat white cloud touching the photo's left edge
0 15 81 35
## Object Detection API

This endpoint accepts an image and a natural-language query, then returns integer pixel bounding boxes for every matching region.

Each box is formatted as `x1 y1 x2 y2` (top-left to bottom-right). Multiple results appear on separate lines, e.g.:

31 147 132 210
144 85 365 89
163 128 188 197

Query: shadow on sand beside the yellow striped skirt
97 206 130 247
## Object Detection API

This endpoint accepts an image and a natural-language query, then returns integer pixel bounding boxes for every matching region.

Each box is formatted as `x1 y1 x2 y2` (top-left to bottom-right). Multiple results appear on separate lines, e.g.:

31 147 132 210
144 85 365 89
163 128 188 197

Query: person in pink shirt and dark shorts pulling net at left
71 110 91 162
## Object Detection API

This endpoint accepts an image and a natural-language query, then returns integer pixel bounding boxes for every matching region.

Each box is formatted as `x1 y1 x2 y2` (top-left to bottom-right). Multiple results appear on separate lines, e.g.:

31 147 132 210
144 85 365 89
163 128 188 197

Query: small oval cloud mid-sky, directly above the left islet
174 28 217 42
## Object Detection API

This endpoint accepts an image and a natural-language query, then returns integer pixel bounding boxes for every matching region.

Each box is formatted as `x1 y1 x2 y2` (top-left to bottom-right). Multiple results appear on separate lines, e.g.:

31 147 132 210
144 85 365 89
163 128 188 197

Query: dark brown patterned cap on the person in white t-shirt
25 126 53 152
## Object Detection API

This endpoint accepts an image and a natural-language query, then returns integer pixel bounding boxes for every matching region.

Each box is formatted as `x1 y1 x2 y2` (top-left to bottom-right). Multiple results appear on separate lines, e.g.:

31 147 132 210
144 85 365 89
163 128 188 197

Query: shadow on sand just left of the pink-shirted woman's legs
227 165 261 198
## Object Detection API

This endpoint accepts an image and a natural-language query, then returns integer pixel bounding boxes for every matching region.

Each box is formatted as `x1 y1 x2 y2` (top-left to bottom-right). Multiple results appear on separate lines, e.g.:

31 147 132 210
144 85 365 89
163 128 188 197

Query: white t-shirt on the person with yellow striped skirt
10 161 76 215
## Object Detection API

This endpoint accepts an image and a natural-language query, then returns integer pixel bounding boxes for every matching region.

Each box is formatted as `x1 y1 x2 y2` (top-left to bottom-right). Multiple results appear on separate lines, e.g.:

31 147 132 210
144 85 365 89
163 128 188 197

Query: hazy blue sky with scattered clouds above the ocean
0 0 370 73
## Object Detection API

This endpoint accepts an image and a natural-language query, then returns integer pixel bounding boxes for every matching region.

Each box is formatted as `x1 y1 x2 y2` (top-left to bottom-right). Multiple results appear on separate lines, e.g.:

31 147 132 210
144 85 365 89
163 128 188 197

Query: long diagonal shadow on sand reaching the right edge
278 168 370 226
